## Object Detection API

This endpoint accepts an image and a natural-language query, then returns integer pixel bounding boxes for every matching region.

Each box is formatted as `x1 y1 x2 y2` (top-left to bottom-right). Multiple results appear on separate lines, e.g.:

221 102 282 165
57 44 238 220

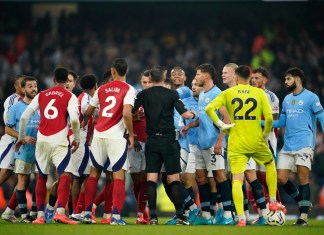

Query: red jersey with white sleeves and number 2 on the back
90 81 135 139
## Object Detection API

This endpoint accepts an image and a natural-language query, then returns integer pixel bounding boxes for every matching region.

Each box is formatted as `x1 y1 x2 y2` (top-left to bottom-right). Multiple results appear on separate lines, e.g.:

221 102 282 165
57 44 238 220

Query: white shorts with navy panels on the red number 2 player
90 137 128 172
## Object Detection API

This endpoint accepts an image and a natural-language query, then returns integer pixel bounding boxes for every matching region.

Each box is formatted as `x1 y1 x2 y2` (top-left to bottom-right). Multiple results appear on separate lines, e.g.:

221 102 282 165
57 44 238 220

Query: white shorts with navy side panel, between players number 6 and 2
69 141 91 178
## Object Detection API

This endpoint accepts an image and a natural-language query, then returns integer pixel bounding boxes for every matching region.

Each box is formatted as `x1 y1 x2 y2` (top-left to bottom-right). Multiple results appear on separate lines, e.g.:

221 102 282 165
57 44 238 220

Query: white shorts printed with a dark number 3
196 147 225 171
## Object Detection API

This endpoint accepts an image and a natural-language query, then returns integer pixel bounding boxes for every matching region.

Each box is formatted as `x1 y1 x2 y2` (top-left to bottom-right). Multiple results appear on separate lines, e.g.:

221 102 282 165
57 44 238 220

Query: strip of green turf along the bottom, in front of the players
0 218 324 235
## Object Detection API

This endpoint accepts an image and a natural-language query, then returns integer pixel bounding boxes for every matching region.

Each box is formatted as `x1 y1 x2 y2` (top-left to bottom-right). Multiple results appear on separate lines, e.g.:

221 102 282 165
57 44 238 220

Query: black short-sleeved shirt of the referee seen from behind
133 86 187 136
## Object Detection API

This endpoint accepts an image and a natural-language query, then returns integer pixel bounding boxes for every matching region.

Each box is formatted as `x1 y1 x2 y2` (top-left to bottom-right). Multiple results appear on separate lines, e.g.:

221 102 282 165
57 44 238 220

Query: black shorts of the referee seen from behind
145 134 181 175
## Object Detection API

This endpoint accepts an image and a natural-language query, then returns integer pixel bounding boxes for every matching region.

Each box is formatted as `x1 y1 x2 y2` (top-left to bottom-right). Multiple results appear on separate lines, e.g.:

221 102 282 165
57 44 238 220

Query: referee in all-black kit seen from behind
133 68 196 225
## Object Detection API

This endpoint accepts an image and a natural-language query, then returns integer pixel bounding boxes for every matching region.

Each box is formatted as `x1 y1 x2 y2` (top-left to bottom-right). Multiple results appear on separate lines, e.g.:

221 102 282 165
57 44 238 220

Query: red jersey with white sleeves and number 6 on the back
29 86 79 145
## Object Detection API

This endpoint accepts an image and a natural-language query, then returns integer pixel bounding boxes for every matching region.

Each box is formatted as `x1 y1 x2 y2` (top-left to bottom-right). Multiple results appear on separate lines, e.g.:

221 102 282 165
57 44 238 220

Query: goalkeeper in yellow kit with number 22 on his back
206 66 278 226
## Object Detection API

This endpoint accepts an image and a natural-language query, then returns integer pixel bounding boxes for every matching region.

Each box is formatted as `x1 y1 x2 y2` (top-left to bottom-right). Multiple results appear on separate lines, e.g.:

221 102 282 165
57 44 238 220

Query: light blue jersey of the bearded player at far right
281 89 323 151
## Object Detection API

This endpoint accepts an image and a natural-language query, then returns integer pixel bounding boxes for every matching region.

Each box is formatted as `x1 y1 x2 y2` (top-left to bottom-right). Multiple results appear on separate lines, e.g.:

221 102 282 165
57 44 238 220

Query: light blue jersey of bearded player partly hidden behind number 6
6 101 40 163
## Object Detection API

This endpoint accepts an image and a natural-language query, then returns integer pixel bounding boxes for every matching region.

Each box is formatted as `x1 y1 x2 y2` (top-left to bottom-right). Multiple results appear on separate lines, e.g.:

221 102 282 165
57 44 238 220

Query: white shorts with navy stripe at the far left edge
0 135 16 170
